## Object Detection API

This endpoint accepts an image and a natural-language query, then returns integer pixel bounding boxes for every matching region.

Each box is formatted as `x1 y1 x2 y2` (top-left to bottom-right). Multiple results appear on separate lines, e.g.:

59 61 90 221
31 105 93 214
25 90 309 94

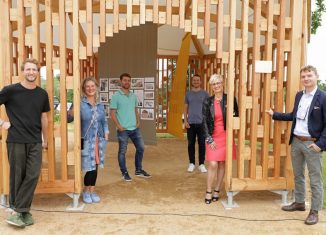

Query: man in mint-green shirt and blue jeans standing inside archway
110 73 151 181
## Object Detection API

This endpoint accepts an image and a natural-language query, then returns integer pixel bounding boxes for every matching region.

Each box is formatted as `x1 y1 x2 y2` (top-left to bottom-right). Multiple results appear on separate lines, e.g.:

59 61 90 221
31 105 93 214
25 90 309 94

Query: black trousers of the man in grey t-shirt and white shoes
187 124 205 165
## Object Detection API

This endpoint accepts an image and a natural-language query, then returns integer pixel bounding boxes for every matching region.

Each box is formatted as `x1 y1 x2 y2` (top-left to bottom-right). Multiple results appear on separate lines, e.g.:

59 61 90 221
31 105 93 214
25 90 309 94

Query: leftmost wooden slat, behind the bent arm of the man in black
0 0 13 195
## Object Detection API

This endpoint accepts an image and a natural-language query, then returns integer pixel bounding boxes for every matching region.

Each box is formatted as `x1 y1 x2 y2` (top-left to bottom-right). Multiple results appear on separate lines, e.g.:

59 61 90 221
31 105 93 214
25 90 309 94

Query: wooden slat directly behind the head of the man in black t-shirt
32 0 40 80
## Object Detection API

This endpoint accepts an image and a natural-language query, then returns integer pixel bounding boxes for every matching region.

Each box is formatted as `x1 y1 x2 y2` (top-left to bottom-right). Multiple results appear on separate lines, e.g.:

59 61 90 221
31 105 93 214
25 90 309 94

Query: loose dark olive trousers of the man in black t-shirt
7 143 42 213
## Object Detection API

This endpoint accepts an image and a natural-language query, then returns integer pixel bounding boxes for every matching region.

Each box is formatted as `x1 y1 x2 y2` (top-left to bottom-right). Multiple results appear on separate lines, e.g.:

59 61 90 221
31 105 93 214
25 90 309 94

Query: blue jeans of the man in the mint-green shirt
117 128 144 174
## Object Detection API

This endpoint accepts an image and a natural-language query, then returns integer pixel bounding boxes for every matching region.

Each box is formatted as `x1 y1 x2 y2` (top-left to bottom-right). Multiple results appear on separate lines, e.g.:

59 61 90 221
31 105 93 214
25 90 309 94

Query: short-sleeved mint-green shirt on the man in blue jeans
110 90 138 131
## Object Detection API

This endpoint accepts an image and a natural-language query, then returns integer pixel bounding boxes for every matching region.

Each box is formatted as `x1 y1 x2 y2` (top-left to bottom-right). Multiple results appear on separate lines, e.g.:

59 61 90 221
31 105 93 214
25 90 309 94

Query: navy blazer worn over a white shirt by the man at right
273 88 326 151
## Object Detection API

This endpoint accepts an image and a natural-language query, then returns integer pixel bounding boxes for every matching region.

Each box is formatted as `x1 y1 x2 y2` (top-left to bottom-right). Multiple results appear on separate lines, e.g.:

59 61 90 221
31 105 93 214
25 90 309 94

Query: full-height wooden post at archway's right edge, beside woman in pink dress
224 1 236 191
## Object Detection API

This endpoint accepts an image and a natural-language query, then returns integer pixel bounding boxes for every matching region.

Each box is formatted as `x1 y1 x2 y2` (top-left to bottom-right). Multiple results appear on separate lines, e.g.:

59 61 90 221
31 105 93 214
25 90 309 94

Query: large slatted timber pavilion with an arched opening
0 0 311 207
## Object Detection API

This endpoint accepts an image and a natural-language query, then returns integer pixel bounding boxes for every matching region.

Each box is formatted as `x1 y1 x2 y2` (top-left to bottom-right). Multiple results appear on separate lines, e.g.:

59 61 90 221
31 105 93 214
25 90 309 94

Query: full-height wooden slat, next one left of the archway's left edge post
59 0 68 181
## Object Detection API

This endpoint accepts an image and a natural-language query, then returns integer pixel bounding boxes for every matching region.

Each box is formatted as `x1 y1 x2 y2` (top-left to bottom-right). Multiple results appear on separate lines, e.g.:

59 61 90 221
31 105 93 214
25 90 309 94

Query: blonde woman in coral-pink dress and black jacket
203 74 238 204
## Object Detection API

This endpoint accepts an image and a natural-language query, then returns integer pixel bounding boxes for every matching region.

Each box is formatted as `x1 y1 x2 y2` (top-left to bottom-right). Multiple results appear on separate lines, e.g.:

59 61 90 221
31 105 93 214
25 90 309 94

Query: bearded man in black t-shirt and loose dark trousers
0 59 50 227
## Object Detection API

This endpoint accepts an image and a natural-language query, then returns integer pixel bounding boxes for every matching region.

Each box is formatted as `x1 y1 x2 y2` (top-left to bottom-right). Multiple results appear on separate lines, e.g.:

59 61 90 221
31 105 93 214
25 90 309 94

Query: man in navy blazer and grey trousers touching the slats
267 65 326 225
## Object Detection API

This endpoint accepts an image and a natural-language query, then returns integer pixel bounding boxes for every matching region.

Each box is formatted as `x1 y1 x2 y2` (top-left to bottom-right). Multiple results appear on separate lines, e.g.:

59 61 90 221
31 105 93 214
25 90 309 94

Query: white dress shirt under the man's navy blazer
293 86 318 137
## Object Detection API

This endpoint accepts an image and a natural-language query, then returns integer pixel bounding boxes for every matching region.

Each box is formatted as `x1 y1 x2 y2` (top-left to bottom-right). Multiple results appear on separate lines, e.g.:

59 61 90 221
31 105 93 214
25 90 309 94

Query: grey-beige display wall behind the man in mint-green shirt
98 23 157 144
